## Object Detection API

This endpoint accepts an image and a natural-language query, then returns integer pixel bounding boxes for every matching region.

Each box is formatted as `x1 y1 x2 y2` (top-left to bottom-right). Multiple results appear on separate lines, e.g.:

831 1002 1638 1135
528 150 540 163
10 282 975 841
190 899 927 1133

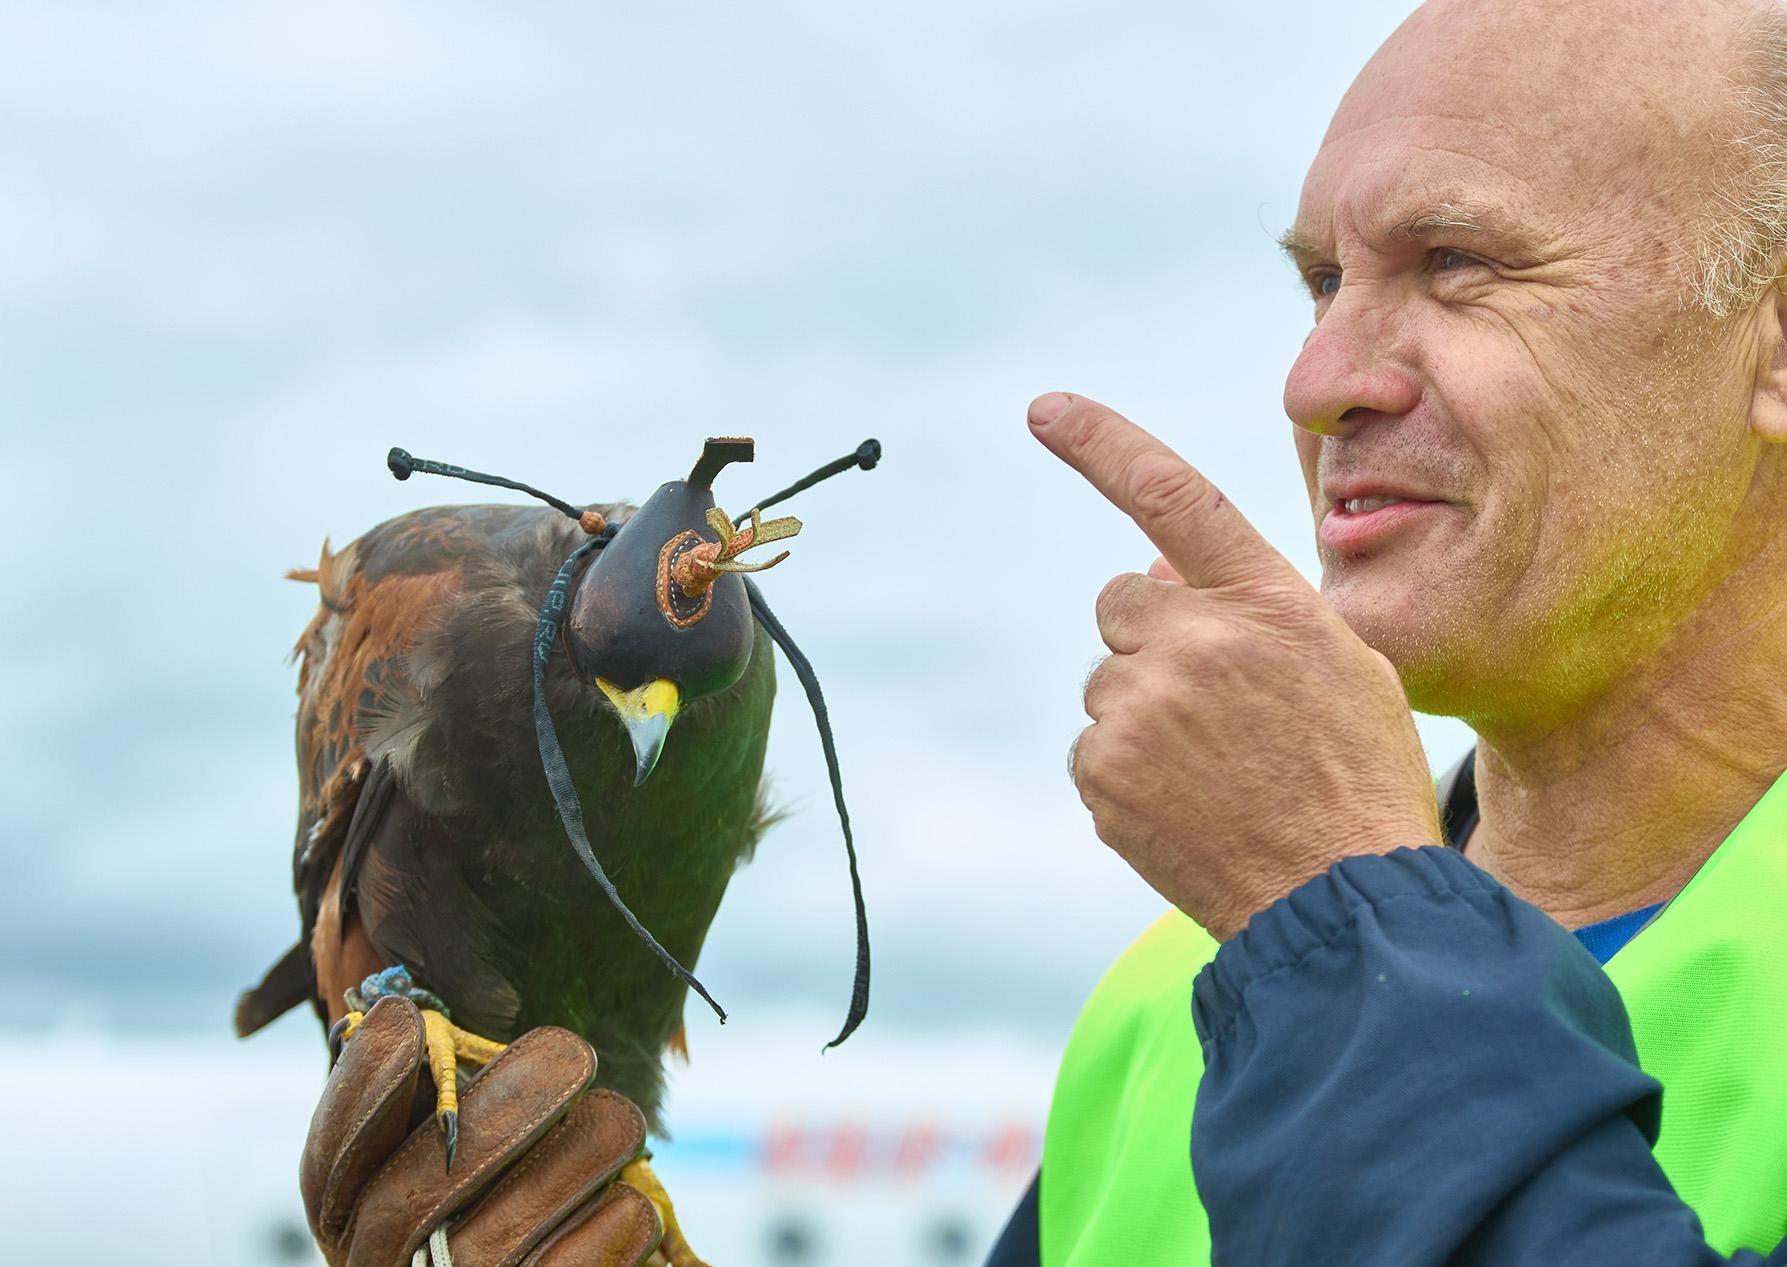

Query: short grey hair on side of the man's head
1691 4 1787 320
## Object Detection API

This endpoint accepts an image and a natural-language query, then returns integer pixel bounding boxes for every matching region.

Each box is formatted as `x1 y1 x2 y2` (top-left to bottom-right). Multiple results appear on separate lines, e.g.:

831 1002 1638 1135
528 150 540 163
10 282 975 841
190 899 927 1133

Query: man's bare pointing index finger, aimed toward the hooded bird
1029 391 1290 586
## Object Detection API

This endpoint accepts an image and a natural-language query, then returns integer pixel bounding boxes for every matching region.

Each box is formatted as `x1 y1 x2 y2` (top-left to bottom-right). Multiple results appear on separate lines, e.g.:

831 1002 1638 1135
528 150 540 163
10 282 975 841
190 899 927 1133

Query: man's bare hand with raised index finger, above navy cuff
1029 393 1440 940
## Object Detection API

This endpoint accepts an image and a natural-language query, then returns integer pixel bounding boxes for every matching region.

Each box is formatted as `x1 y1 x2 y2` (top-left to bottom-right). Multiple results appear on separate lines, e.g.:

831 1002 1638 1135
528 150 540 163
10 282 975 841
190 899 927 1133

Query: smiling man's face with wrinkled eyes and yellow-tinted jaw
1285 0 1755 717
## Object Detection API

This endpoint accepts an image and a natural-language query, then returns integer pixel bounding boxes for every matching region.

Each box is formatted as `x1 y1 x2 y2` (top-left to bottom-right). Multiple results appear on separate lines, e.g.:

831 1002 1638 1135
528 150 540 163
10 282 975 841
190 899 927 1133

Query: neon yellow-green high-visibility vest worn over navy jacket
1038 774 1787 1267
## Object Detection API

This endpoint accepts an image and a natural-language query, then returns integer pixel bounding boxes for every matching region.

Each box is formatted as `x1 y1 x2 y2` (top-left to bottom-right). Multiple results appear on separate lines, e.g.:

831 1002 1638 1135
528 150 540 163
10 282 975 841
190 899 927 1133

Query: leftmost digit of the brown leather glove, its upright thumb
298 997 424 1262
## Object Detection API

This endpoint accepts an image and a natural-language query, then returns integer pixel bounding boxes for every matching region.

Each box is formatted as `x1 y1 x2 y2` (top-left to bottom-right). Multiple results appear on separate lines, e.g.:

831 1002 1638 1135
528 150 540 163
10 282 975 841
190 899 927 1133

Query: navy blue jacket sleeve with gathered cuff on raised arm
1192 847 1787 1267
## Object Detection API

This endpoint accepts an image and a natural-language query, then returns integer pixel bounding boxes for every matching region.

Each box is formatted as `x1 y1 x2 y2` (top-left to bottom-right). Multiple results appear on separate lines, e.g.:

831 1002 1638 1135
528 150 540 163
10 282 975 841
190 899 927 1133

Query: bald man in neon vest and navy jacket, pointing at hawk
307 0 1787 1267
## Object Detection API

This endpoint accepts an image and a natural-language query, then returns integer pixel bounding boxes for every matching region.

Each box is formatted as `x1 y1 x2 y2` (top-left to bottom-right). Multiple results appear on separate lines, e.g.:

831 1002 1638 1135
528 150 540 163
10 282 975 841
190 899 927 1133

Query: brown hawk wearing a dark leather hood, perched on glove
236 440 879 1158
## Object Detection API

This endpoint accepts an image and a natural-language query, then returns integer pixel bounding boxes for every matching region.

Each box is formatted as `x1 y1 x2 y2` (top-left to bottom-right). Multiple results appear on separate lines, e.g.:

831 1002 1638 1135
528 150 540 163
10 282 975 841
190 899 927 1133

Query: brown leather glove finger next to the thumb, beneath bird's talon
347 1026 595 1267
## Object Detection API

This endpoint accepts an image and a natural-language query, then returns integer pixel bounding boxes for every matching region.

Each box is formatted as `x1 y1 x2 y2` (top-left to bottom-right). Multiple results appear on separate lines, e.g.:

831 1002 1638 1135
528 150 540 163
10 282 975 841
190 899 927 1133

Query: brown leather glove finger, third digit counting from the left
452 1090 645 1267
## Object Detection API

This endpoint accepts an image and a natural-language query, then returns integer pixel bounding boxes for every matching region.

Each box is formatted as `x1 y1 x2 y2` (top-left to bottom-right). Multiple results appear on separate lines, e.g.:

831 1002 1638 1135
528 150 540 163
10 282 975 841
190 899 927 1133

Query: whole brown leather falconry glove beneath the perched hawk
300 997 693 1267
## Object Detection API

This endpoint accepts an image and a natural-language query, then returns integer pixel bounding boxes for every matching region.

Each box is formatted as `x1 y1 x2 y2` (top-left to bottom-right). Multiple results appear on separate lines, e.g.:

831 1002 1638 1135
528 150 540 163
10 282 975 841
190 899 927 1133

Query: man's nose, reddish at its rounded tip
1285 293 1421 436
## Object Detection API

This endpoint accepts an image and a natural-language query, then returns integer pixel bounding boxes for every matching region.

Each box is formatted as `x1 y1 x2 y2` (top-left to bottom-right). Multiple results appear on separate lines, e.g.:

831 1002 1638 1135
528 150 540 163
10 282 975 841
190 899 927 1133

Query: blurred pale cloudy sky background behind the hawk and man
0 0 1469 1267
